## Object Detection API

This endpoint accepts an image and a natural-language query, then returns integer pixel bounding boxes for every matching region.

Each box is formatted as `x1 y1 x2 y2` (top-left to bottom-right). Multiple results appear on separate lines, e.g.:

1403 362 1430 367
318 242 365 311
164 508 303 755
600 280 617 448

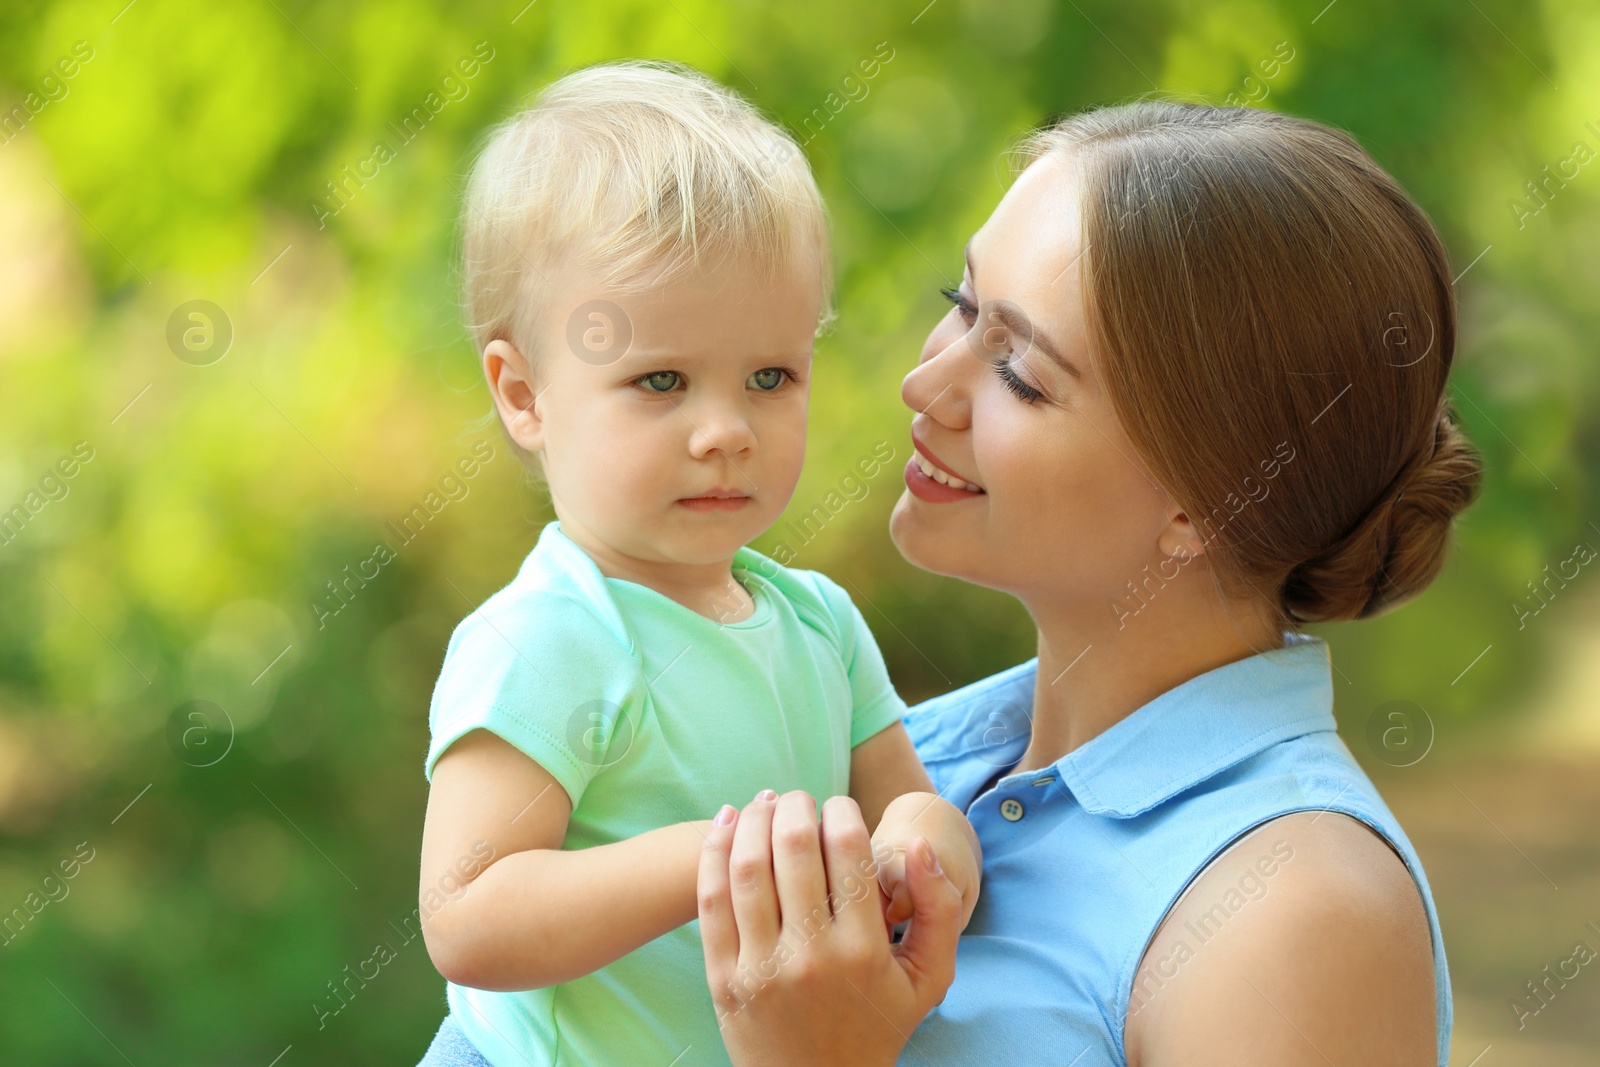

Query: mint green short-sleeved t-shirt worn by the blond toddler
424 522 906 1067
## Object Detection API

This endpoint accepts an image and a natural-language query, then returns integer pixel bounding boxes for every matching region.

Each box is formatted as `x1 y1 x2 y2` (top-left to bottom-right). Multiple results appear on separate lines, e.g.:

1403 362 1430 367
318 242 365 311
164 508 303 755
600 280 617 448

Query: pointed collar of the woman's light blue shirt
914 632 1336 819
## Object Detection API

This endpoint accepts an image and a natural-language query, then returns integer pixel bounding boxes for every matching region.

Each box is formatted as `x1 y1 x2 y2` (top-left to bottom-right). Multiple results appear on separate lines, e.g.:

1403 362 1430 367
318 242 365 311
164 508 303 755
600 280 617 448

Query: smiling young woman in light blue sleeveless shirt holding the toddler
699 102 1482 1067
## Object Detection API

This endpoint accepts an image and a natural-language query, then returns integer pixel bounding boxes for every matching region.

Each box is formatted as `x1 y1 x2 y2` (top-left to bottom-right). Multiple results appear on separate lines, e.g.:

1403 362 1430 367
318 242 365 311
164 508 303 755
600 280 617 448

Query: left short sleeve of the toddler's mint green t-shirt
422 587 645 808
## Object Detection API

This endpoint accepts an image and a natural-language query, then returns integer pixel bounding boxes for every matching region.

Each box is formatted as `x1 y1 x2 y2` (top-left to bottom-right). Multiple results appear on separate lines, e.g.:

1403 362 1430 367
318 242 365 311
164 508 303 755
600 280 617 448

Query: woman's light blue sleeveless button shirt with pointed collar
899 632 1453 1067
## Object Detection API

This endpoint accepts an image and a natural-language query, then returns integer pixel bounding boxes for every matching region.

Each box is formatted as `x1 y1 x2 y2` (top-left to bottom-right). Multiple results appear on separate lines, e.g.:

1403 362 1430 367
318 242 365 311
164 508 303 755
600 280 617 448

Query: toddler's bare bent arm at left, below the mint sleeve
419 729 710 990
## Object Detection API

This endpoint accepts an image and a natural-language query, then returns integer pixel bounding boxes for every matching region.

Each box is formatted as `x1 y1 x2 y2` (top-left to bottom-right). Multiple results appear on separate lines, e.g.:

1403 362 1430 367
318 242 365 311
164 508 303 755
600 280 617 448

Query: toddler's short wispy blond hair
461 61 832 360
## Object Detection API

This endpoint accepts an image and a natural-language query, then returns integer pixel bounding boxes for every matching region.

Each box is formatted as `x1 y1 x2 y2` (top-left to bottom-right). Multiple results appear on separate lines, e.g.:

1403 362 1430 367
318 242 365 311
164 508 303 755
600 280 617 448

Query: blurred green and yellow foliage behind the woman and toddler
0 0 1600 1067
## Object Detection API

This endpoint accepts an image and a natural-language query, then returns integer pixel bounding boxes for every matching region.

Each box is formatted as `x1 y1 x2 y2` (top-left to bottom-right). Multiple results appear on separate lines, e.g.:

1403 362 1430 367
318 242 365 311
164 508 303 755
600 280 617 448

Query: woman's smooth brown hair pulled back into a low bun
1022 101 1483 624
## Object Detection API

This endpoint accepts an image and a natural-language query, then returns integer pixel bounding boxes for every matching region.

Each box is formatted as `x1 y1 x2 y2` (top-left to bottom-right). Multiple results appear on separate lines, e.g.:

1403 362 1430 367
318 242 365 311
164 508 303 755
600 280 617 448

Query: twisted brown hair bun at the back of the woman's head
1278 400 1483 622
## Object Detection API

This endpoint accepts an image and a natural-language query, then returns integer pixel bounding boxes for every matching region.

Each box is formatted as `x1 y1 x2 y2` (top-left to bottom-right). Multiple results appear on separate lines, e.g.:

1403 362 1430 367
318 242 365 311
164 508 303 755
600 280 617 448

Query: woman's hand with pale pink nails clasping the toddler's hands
699 790 962 1067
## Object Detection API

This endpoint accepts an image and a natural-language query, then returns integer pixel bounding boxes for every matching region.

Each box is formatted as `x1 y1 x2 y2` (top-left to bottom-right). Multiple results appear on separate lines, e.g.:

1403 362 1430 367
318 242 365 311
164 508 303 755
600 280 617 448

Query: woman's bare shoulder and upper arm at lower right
1125 811 1438 1067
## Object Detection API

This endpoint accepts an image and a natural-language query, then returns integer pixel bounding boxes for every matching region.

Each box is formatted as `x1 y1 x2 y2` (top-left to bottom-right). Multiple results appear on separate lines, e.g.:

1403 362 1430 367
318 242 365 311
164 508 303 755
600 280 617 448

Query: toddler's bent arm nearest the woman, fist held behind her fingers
850 723 984 929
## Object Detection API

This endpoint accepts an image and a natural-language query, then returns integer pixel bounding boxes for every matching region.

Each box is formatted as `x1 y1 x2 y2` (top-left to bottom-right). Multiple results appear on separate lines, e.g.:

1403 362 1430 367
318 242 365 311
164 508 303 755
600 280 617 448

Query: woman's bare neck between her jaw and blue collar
1011 589 1283 773
